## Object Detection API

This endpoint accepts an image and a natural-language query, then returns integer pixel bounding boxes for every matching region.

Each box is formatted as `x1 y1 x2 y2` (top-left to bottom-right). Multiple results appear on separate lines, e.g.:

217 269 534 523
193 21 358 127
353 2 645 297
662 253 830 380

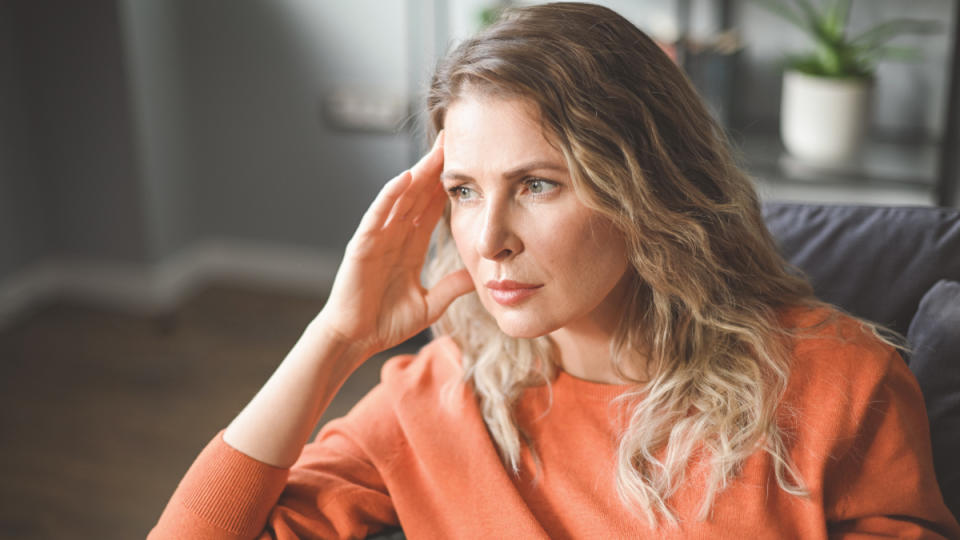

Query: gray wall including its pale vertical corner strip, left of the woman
122 0 422 257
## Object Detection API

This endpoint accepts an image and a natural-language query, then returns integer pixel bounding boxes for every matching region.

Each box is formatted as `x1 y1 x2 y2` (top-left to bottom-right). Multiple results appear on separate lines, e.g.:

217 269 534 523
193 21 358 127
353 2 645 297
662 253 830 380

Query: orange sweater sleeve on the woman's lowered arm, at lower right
824 349 960 538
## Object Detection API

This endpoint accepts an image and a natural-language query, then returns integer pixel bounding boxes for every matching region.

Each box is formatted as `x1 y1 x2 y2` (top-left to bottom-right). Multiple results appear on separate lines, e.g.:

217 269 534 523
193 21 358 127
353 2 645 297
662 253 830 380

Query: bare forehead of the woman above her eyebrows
444 95 565 172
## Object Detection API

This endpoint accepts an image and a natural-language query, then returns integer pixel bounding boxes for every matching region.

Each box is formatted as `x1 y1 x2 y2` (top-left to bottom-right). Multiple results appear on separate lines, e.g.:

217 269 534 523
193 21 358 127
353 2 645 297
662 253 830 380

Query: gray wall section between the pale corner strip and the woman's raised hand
179 0 410 249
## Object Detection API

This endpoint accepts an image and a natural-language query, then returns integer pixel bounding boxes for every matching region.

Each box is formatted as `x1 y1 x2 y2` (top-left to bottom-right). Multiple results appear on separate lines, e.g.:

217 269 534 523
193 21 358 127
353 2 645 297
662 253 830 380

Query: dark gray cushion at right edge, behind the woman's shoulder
907 280 960 516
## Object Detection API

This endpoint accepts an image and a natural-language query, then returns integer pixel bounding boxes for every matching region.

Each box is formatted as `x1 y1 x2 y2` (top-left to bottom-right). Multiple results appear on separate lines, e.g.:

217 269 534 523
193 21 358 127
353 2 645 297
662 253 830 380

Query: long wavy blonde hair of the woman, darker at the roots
427 3 860 523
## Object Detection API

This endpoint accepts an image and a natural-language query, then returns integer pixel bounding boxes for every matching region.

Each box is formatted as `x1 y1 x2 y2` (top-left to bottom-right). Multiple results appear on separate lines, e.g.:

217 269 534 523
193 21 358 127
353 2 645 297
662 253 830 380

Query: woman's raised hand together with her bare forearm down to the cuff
223 136 473 467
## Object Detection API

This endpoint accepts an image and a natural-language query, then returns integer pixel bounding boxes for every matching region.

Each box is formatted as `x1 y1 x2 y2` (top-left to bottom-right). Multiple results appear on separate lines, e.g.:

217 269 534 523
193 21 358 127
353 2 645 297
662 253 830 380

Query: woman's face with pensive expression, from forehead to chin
441 95 628 338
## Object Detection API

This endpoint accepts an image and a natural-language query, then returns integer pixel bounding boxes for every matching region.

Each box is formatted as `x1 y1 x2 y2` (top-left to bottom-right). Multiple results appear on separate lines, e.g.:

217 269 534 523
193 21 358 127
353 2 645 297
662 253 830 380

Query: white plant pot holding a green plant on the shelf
780 71 873 166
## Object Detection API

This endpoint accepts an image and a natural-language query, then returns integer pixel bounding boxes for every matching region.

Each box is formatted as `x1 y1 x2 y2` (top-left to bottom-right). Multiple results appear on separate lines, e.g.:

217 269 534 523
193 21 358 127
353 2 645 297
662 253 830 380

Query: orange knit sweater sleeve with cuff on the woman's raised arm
148 358 412 540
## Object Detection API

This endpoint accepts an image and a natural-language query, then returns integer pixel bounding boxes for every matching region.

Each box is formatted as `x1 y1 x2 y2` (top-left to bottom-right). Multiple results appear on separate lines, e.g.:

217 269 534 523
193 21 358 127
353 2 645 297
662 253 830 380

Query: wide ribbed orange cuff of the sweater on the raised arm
150 431 290 539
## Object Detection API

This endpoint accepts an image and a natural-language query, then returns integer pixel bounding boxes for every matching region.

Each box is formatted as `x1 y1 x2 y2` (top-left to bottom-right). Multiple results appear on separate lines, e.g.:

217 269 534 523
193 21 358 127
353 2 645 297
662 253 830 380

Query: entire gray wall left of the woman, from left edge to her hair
0 0 422 286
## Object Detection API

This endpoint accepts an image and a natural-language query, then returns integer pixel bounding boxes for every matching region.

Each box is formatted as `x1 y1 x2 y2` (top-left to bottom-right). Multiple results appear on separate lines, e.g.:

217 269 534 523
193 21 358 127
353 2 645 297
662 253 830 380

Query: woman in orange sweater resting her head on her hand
152 4 960 538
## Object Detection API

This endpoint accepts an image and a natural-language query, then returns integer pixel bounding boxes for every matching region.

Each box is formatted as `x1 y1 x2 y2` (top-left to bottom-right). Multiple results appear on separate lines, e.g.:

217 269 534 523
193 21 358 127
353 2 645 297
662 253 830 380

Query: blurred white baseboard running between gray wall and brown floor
0 240 342 328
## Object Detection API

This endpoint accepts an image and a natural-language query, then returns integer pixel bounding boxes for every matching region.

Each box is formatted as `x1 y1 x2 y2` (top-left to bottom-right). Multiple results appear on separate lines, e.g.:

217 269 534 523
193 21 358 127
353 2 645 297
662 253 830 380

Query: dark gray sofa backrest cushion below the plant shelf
763 202 960 334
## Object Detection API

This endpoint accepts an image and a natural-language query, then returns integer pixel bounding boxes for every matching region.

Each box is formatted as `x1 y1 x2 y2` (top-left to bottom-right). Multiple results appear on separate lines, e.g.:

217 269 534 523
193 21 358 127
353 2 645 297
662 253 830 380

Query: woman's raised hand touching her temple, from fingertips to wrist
313 132 473 358
